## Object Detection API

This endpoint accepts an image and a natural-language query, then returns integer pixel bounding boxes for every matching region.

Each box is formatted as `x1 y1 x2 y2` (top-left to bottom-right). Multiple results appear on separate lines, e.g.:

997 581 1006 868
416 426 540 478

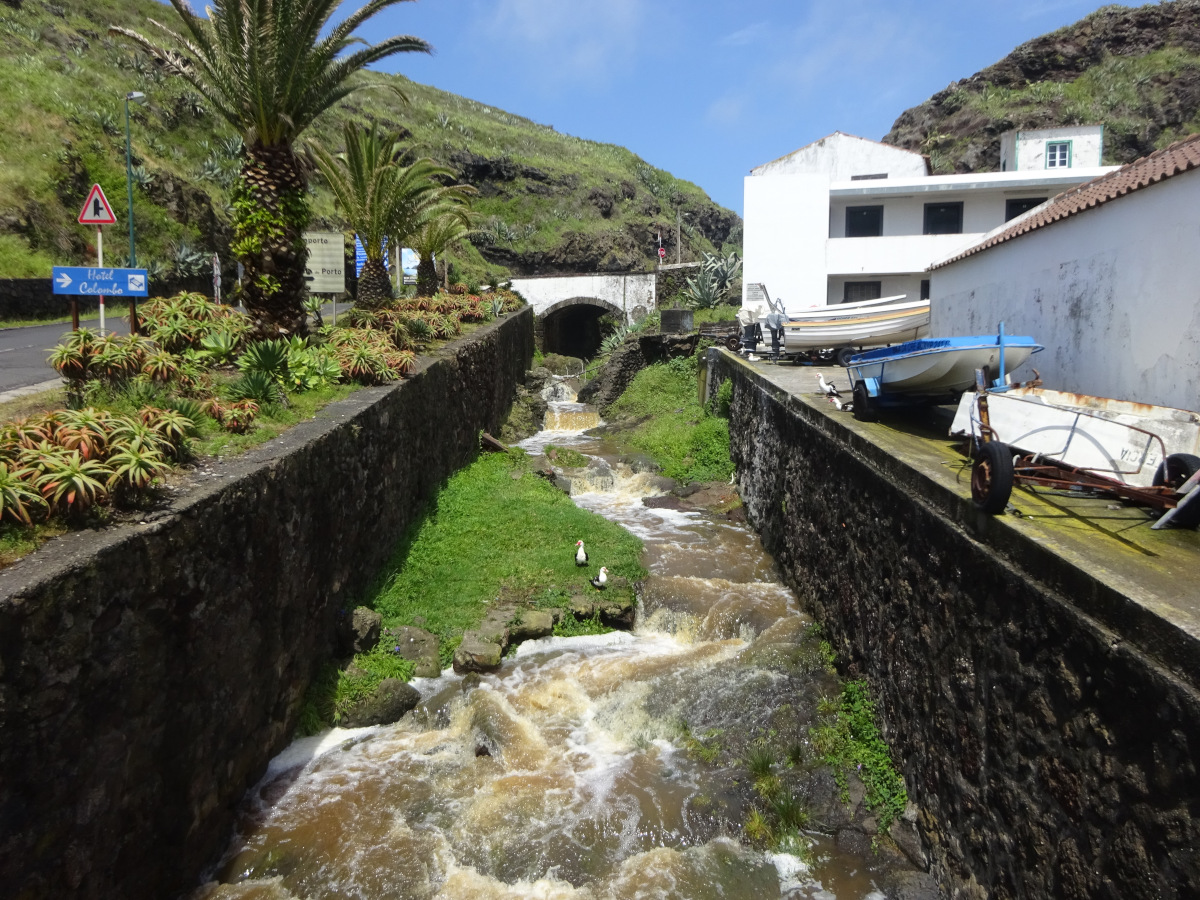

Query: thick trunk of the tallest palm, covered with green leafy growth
232 145 310 338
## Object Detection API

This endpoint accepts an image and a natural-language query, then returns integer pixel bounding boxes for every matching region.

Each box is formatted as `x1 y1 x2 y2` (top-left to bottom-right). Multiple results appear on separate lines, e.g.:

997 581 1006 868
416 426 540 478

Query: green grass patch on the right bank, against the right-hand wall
608 350 733 482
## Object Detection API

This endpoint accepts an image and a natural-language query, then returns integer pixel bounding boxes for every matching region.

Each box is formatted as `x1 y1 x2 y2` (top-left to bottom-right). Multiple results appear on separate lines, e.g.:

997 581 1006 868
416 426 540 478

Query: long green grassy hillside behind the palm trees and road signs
0 0 740 283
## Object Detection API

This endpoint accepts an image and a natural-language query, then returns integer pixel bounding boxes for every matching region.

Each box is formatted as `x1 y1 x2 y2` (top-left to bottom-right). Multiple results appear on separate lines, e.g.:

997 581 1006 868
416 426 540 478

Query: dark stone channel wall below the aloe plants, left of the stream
0 308 533 898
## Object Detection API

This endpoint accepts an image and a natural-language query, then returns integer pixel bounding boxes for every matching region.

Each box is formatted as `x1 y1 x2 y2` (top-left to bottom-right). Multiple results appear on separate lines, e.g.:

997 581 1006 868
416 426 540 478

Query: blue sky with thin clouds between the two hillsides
274 0 1102 212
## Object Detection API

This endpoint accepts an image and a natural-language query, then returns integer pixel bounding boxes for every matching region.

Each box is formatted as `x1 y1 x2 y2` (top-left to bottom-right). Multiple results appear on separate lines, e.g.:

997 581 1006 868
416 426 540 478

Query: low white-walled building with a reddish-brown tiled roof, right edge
930 136 1200 410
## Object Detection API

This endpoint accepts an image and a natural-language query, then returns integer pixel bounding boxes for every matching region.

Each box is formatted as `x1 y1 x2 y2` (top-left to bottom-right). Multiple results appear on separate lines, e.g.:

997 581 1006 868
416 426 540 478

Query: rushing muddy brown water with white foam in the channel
198 393 921 900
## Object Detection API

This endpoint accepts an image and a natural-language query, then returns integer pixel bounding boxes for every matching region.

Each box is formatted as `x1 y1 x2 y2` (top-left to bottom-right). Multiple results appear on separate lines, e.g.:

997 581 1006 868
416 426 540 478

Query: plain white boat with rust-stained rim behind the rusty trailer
950 388 1200 487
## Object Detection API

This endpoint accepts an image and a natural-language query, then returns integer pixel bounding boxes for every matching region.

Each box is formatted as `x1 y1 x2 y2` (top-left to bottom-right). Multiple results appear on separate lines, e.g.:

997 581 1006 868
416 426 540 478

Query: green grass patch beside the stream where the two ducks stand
367 454 644 643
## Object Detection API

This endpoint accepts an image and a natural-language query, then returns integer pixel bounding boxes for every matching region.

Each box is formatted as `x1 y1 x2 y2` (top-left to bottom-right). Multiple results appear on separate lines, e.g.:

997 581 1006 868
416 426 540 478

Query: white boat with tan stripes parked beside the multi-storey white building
784 294 929 356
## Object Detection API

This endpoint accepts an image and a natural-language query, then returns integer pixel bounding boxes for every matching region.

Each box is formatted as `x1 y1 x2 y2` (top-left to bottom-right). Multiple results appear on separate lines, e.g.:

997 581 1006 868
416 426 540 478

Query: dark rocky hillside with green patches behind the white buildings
883 0 1200 173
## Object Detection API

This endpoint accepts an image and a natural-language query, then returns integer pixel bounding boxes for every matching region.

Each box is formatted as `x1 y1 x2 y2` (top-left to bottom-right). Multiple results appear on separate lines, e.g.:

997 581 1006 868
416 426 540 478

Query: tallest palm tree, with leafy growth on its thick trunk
110 0 430 337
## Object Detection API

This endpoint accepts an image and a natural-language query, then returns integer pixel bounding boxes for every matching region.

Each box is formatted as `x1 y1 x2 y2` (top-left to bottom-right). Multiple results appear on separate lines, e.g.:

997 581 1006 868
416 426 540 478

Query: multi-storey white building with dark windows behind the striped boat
743 132 1111 310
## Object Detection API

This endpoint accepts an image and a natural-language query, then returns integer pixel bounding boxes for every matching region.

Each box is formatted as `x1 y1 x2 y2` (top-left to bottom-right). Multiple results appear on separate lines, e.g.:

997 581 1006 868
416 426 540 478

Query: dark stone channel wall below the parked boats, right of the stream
709 350 1200 900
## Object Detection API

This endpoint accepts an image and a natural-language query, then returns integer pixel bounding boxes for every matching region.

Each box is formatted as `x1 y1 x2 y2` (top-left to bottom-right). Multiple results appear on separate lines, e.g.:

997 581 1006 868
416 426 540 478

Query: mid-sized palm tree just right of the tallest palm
311 122 474 307
